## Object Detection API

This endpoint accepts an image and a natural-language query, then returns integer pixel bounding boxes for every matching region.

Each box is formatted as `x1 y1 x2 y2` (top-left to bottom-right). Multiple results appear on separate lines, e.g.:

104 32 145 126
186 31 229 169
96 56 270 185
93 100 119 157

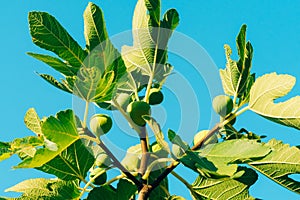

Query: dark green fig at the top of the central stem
127 101 151 126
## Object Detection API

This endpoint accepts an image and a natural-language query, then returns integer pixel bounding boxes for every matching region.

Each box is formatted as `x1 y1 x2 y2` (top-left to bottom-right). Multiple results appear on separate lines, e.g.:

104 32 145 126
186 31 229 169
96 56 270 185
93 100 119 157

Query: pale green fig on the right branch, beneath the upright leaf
212 95 233 117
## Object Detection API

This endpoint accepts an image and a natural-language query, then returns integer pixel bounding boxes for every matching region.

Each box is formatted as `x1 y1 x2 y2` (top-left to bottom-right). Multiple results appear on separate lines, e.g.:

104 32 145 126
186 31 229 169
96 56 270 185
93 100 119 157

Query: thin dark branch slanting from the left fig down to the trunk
85 128 143 189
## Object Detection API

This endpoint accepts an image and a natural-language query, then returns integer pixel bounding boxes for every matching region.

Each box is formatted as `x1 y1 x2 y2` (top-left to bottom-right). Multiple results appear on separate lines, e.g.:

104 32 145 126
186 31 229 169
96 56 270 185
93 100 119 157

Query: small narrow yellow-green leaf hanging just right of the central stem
143 116 170 153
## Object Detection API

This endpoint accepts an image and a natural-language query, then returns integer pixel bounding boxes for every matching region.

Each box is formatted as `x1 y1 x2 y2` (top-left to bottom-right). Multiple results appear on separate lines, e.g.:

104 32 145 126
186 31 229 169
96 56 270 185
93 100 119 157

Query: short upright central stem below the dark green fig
138 126 150 177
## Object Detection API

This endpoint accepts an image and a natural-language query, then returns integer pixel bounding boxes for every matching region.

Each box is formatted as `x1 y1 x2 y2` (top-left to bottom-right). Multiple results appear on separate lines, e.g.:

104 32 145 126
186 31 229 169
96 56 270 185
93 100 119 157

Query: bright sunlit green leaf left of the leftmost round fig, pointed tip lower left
15 110 79 168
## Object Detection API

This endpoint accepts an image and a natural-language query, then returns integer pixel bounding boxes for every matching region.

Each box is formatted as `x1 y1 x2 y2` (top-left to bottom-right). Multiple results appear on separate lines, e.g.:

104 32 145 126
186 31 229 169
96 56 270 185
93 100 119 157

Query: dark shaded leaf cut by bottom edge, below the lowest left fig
87 186 117 200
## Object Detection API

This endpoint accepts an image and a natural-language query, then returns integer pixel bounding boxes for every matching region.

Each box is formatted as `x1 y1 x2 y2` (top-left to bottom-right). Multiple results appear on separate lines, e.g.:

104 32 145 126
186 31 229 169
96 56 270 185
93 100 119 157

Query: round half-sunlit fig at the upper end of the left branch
90 114 112 137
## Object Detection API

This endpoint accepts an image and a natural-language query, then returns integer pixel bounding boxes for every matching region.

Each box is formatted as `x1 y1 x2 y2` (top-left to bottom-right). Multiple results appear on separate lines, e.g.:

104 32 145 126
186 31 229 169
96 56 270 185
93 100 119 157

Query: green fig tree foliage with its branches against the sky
0 0 300 200
